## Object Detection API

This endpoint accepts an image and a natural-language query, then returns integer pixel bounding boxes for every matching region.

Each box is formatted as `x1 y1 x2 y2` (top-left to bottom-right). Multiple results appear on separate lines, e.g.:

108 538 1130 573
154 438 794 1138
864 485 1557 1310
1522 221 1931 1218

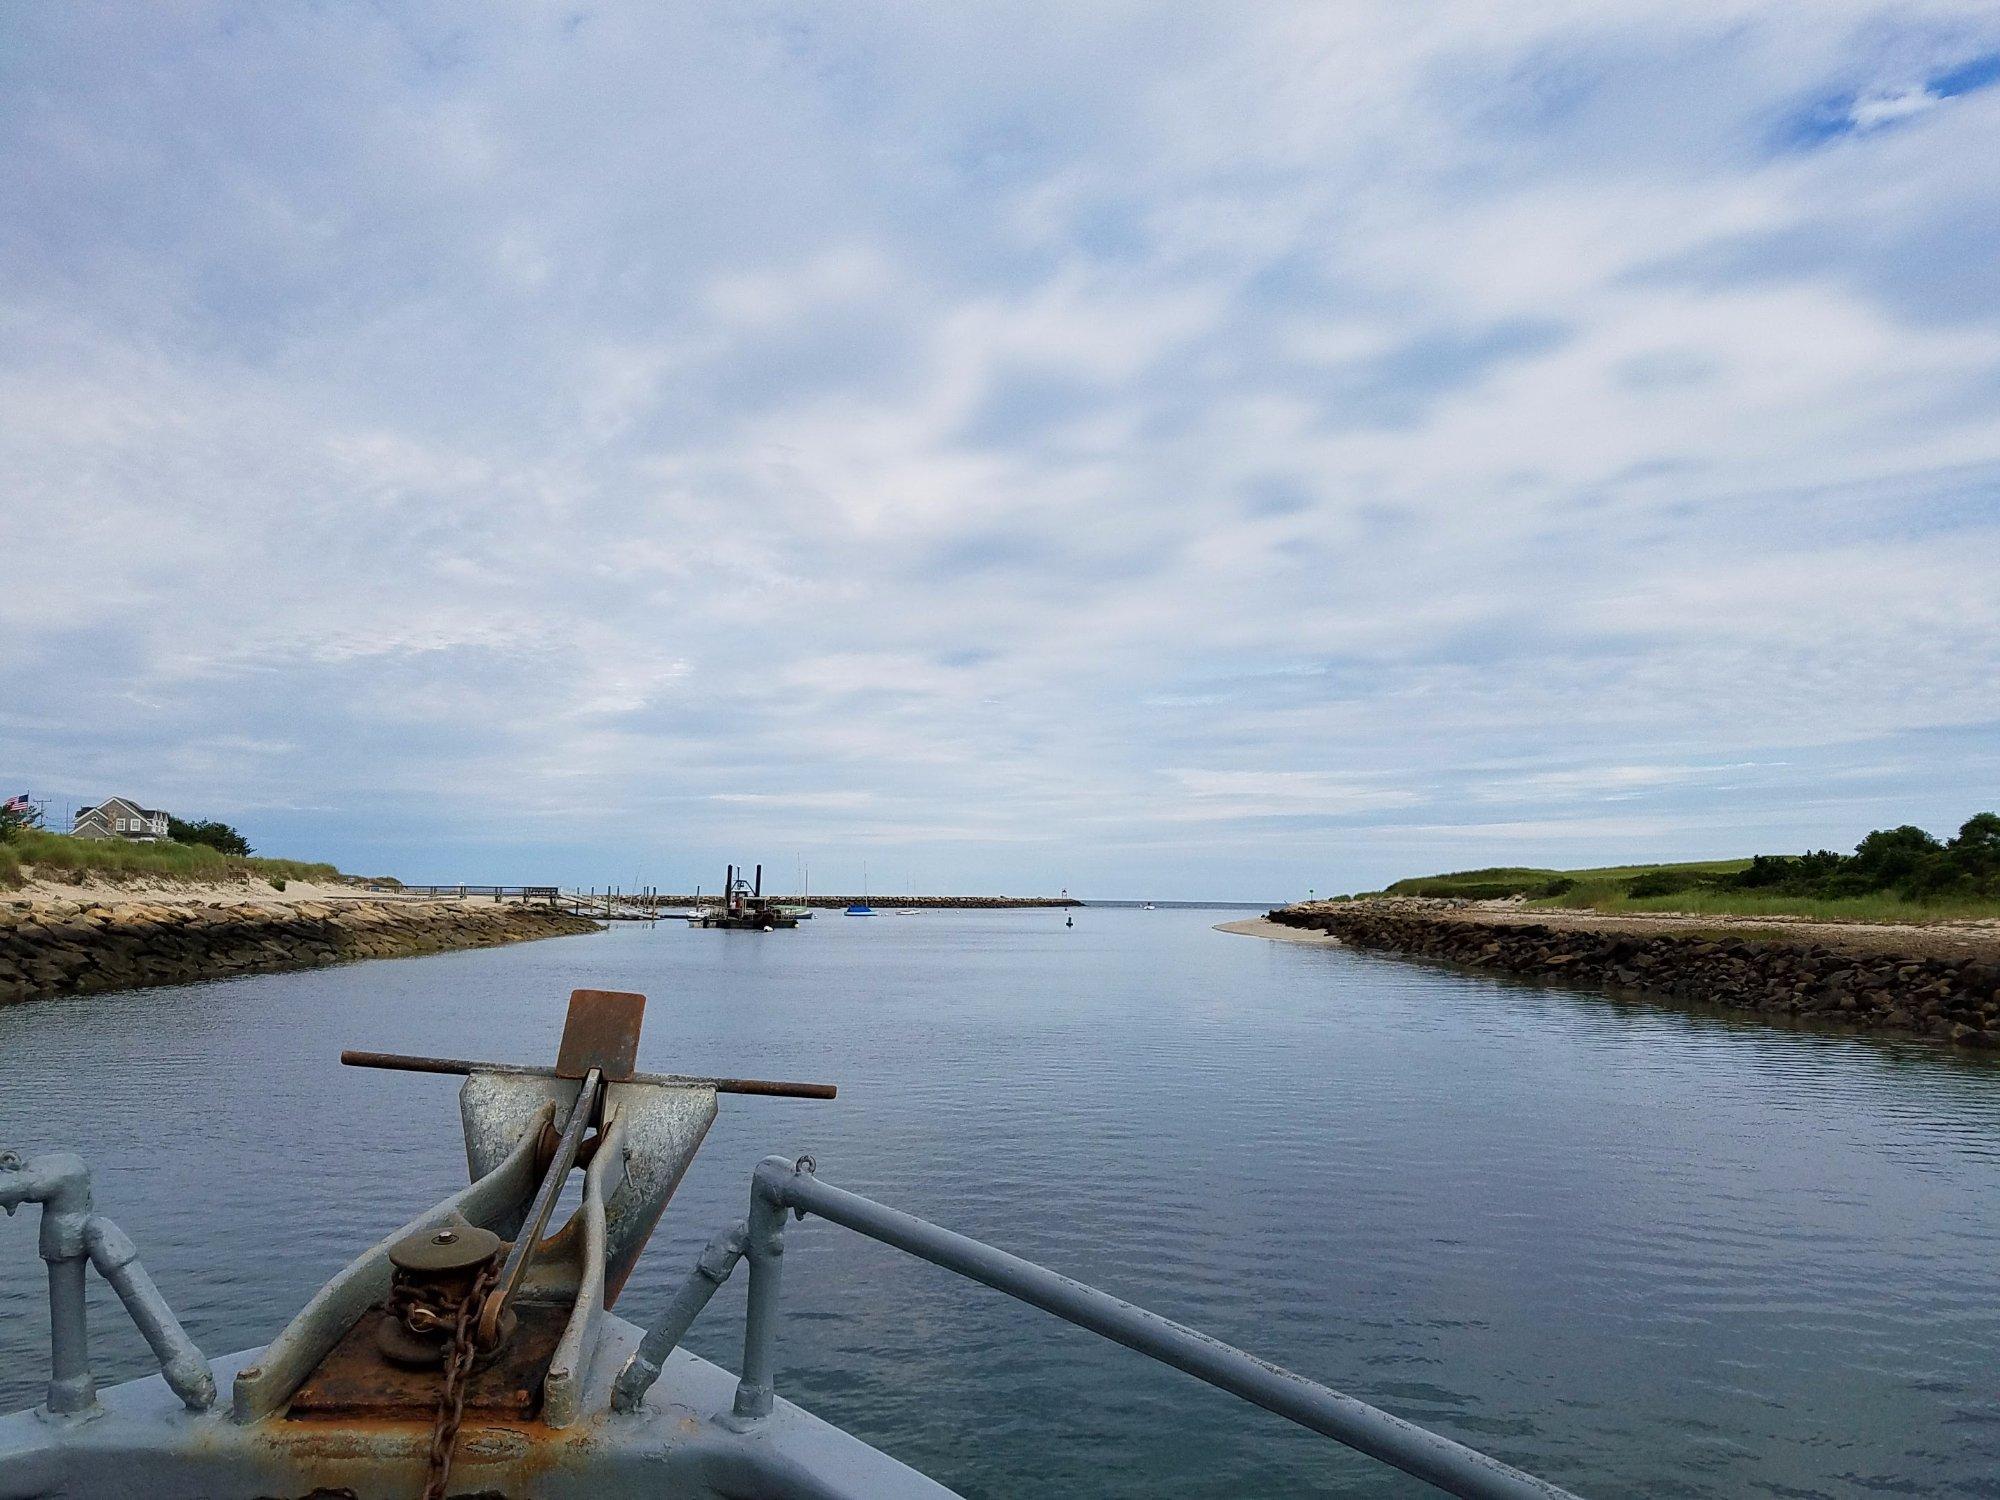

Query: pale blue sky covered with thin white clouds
0 0 2000 900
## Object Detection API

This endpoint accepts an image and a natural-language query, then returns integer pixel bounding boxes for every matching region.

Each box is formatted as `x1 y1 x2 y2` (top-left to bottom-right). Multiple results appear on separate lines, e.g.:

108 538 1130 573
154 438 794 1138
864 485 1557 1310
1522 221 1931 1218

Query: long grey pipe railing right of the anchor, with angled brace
612 1156 1576 1500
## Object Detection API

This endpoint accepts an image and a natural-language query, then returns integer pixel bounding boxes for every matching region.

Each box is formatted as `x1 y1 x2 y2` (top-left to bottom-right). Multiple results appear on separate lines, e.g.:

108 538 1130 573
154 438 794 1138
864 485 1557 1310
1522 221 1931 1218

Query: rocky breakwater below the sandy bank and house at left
0 900 598 1004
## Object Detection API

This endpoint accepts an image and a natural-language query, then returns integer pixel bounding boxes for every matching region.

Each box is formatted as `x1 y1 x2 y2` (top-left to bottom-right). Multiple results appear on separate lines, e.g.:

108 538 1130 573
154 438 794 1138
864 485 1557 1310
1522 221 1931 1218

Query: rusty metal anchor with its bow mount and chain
236 990 838 1428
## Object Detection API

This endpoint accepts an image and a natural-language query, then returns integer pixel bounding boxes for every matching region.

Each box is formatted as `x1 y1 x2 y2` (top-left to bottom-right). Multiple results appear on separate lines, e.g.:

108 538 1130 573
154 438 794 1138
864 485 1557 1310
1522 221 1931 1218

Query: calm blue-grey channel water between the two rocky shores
0 910 2000 1500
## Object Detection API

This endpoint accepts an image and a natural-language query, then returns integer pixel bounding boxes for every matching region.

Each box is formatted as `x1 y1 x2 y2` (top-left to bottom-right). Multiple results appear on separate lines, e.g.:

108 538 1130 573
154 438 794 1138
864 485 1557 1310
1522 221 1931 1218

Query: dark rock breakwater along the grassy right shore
1270 902 2000 1048
